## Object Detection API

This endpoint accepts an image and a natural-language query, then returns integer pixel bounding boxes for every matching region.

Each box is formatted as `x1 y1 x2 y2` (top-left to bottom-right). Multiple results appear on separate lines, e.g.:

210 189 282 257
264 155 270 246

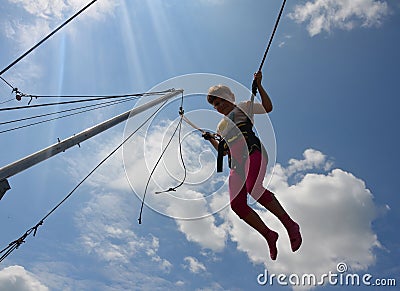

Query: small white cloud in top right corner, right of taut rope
289 0 389 36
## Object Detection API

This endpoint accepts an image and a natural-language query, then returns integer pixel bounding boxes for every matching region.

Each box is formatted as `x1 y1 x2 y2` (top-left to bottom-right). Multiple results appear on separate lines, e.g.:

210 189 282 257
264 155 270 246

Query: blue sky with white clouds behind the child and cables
0 0 400 291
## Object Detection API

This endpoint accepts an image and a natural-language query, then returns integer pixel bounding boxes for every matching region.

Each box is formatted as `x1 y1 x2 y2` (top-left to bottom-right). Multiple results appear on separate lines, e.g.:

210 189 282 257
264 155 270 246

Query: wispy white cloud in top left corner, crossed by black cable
0 0 120 88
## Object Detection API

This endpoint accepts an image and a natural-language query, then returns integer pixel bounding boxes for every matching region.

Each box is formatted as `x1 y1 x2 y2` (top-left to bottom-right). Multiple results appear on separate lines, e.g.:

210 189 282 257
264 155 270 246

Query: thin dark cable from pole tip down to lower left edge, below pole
0 100 167 262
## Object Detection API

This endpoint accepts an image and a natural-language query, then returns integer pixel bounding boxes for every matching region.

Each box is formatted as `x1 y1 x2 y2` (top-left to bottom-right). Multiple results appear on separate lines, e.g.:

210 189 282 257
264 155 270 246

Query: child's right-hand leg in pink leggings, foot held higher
246 151 302 252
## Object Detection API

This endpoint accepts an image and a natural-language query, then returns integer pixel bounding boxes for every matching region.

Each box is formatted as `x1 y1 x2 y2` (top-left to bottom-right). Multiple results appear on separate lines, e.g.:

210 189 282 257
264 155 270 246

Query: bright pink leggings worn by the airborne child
229 144 274 219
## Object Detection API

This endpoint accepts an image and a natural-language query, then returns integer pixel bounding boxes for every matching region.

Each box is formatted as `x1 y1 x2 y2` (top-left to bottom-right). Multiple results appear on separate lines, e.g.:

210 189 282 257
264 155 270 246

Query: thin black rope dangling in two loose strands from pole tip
138 92 187 224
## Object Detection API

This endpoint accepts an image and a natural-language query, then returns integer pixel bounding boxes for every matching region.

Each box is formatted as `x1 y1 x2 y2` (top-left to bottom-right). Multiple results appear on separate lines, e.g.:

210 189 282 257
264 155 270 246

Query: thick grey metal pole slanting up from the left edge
0 89 183 199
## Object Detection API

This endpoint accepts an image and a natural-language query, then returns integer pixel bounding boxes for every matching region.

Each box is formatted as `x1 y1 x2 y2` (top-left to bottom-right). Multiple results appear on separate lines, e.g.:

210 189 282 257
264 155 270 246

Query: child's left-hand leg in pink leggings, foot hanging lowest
229 170 278 260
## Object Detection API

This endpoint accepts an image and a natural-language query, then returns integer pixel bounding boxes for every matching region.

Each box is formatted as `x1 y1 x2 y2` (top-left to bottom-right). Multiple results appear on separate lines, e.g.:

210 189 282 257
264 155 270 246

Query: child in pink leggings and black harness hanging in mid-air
203 71 302 260
